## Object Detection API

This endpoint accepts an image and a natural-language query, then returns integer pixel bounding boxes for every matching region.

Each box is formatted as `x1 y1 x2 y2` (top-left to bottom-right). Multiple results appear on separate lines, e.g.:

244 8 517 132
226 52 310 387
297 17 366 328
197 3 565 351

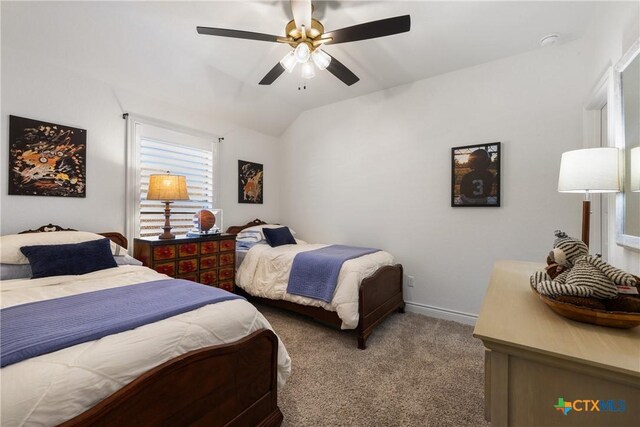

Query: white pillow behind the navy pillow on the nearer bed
0 231 127 264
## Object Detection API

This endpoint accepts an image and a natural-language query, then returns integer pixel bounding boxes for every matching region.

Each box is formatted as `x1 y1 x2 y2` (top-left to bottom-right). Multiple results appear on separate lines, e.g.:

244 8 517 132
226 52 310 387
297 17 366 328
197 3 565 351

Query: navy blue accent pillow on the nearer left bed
20 239 118 279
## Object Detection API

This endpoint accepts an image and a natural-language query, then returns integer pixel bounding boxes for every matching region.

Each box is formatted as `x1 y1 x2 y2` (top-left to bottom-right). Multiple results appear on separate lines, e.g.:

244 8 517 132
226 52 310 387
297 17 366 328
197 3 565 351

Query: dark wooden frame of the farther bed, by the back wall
227 219 404 350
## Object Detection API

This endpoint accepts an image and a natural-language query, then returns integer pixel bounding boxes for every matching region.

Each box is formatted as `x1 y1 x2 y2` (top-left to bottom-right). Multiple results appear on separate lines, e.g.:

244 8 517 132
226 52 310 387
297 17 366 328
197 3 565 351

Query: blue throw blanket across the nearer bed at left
0 279 242 366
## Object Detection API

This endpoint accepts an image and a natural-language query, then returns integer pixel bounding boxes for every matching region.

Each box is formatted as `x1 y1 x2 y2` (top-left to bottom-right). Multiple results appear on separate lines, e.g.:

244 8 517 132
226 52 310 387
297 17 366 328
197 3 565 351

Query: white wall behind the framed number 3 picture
281 40 587 321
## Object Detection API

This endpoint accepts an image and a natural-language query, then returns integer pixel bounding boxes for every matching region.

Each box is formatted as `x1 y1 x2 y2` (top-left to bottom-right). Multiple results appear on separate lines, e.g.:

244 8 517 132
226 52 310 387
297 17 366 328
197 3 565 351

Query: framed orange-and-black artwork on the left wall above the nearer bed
9 116 87 197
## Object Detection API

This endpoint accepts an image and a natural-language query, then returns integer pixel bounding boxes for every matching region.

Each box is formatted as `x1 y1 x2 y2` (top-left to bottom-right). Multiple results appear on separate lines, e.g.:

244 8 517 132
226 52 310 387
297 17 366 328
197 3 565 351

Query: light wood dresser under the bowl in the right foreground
473 261 640 427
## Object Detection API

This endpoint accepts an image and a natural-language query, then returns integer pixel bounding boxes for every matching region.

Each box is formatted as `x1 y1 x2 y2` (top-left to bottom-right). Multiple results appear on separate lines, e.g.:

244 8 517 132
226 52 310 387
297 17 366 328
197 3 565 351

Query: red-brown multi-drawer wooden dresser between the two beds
133 234 236 292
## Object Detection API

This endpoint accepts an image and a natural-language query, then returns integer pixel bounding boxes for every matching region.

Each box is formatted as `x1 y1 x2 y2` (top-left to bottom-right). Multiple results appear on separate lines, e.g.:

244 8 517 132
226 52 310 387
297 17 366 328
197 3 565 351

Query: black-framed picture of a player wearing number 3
451 142 500 207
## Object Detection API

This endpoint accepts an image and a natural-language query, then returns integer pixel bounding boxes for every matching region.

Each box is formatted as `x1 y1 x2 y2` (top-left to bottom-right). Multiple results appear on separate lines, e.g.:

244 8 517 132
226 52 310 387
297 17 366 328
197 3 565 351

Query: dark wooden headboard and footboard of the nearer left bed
17 224 283 427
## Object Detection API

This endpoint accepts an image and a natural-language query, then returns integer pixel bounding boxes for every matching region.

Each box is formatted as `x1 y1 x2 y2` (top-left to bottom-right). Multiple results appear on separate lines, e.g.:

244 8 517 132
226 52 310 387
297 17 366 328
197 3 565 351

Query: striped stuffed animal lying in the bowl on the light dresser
530 231 636 299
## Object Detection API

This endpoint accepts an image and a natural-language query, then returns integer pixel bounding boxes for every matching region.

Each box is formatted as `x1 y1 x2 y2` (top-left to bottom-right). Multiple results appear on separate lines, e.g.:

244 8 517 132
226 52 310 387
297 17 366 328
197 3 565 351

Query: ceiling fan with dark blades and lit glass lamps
197 0 411 86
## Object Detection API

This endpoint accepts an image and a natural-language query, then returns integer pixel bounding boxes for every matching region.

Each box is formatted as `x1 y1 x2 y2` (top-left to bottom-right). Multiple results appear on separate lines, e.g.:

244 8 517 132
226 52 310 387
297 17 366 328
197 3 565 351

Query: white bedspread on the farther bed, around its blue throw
236 243 395 329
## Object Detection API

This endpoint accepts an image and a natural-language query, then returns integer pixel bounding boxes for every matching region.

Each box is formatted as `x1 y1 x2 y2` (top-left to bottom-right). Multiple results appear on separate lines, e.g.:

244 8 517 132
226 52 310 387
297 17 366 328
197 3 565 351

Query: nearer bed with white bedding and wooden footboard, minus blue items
0 226 291 427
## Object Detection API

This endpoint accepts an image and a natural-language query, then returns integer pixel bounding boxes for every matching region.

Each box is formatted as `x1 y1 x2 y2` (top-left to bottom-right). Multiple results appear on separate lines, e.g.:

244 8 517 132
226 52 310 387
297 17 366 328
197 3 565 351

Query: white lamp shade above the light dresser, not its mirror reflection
558 147 620 193
